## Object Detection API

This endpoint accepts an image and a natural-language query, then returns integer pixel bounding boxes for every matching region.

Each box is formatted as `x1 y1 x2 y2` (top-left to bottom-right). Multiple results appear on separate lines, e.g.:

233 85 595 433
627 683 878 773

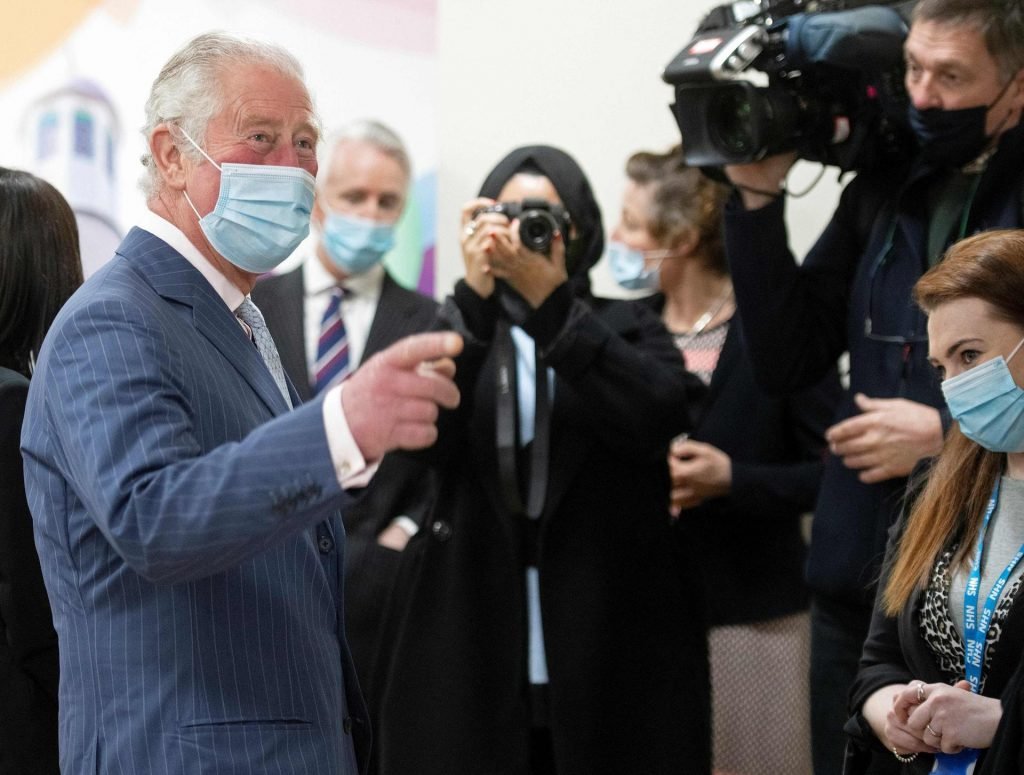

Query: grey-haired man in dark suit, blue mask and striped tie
253 120 438 711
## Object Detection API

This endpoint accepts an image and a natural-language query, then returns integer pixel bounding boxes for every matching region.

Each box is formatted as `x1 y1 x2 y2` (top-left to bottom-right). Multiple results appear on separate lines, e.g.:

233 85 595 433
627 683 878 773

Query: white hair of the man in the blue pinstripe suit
139 32 315 200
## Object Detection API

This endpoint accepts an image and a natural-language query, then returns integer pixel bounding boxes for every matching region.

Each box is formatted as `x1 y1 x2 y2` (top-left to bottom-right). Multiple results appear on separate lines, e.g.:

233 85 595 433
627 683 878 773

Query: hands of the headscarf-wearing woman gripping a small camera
461 197 568 309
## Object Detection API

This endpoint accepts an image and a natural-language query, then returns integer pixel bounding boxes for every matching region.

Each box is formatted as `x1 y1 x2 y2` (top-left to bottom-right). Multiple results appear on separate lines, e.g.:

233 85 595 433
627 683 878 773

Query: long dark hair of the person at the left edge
0 167 82 376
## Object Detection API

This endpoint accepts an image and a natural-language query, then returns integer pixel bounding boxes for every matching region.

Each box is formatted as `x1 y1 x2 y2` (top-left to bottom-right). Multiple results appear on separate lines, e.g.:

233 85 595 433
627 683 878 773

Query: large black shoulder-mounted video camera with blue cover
663 0 915 172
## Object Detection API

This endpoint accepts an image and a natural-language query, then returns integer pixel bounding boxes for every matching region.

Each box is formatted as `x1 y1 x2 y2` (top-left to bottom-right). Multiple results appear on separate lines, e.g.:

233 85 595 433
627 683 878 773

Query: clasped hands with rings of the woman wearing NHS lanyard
885 681 1002 754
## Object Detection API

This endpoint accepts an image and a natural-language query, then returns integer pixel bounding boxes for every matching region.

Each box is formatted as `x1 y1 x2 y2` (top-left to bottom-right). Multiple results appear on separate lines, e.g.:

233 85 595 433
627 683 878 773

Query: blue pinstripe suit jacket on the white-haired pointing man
22 228 369 775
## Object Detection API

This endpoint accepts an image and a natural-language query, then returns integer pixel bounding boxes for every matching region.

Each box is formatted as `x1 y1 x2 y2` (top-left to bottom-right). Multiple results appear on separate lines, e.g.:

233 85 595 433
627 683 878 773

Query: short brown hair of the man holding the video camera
910 0 1024 79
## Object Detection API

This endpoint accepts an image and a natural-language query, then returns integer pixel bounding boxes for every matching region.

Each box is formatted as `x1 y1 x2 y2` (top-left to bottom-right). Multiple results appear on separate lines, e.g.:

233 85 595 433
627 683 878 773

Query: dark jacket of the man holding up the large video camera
725 124 1024 606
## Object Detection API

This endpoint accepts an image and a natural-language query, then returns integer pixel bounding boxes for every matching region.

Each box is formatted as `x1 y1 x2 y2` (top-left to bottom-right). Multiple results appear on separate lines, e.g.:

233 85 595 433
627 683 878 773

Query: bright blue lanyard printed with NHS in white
932 479 1024 775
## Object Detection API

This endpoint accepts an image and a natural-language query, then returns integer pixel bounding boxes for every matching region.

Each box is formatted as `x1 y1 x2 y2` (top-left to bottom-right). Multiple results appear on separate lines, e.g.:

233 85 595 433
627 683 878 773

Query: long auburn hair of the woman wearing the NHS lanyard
883 229 1024 616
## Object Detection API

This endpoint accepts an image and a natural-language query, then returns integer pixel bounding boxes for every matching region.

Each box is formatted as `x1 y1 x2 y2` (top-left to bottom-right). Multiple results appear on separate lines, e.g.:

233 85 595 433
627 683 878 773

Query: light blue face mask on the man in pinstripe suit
181 129 315 274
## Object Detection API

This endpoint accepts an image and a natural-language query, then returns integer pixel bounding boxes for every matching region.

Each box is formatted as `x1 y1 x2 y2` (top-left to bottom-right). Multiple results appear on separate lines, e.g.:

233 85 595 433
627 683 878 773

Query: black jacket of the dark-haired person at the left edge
0 368 58 775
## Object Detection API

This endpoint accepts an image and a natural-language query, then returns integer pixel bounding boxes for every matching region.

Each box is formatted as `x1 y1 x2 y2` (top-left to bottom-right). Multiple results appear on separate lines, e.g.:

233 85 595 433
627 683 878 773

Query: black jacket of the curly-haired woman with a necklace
651 295 841 626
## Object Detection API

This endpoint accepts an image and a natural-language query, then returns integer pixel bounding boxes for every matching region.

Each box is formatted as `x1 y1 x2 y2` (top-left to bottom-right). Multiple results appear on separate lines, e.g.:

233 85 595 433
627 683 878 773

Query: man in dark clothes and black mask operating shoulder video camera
725 0 1024 775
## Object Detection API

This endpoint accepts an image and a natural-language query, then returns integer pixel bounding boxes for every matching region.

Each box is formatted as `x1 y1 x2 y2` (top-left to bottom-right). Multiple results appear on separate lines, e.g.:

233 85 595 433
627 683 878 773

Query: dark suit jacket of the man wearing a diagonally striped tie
252 258 438 715
